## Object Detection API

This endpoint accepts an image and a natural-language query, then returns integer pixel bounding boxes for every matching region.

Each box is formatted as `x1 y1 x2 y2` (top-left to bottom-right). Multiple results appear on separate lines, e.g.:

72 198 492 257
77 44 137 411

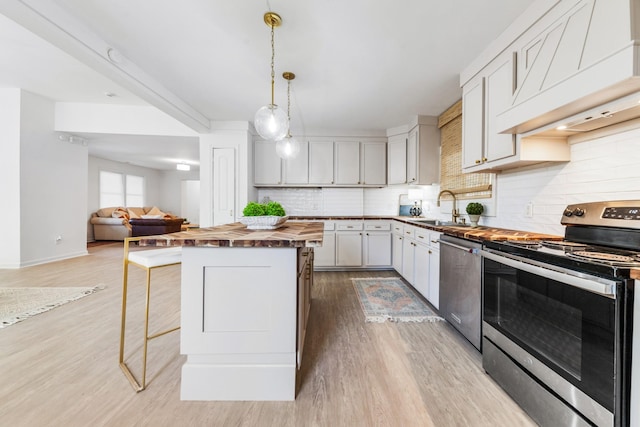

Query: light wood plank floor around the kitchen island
0 243 535 427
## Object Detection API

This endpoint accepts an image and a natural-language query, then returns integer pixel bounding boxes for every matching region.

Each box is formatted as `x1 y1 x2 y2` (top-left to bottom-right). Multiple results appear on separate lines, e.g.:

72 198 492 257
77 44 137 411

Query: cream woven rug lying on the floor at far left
0 286 104 328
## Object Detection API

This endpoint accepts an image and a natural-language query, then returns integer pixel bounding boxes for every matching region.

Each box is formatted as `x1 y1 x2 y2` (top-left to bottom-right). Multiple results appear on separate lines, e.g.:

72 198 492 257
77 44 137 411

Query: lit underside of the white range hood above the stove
522 92 640 138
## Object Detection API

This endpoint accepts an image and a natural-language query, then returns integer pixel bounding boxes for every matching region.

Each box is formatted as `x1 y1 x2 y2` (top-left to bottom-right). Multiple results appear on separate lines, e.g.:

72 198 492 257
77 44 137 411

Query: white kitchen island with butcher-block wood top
140 222 323 400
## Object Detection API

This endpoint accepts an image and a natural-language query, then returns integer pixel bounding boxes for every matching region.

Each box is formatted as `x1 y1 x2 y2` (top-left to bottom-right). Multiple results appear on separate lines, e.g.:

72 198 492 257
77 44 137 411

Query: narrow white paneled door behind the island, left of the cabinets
211 148 236 225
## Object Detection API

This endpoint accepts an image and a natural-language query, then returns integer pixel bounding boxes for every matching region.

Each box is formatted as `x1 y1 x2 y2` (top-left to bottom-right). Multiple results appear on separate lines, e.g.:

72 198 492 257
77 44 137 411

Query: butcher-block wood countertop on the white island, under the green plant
140 221 324 248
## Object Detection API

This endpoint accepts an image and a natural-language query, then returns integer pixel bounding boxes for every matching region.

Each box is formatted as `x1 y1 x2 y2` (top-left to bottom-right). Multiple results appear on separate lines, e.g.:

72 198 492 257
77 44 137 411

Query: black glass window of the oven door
483 259 615 410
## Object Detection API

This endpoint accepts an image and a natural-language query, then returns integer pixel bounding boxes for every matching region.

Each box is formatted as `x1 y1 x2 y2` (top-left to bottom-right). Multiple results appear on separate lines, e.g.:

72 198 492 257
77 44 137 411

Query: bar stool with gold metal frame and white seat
120 237 182 392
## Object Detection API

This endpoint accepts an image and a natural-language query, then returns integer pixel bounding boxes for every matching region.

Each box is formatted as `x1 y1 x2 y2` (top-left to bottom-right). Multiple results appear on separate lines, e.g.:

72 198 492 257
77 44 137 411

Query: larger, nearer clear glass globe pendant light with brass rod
253 12 289 141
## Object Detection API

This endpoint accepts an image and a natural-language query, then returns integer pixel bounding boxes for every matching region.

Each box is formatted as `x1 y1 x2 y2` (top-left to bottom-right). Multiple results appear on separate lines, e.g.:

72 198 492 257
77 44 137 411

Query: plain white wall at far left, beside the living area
0 89 87 268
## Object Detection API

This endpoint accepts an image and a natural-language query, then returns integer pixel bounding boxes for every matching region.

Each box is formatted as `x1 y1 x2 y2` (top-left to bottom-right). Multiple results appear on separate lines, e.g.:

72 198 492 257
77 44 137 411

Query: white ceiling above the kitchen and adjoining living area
0 0 533 169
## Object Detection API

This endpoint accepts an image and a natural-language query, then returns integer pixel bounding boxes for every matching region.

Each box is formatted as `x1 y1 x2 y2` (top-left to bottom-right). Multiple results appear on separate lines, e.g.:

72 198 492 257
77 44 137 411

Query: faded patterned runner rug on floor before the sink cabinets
351 277 444 323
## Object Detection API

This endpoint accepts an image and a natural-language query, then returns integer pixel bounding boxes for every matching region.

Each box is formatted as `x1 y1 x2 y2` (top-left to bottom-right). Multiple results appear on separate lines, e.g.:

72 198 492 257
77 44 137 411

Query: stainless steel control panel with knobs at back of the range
560 200 640 229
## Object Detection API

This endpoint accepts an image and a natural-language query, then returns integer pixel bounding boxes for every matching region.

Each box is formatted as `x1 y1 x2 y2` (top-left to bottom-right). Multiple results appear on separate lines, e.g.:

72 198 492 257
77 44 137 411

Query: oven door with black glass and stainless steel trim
482 249 624 424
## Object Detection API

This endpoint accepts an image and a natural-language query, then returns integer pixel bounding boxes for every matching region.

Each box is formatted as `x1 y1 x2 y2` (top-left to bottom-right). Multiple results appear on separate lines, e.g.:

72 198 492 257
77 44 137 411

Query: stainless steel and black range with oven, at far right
482 200 640 426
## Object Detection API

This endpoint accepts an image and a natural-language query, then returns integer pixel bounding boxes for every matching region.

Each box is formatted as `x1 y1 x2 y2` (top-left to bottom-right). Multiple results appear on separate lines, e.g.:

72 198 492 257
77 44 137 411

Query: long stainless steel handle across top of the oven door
480 249 617 298
